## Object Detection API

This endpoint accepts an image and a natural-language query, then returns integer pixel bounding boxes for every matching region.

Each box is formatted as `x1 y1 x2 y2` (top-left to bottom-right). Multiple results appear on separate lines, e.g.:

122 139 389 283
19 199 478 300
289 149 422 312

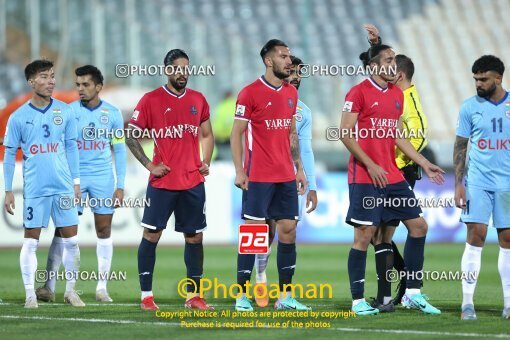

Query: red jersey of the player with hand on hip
129 85 209 190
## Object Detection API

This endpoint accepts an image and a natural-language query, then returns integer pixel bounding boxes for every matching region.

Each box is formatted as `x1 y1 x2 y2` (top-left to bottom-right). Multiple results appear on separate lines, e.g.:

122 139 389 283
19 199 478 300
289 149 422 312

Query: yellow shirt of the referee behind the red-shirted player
395 85 428 169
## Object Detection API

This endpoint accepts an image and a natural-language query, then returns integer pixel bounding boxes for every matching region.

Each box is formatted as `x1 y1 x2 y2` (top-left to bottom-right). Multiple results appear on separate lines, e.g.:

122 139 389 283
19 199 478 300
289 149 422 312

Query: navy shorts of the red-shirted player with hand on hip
141 183 207 234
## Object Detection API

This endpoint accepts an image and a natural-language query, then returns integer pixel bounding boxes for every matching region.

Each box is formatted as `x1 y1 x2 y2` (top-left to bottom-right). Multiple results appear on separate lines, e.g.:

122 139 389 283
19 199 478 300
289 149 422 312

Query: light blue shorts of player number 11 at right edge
460 185 510 229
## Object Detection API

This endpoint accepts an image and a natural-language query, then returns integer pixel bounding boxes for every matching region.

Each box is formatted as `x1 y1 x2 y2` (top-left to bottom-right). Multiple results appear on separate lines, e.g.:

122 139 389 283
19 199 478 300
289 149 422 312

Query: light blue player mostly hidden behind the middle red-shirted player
255 56 317 307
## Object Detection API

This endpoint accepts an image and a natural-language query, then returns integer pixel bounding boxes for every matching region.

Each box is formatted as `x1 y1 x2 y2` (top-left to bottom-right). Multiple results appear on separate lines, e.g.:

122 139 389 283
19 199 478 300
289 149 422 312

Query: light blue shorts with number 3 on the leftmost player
23 192 78 228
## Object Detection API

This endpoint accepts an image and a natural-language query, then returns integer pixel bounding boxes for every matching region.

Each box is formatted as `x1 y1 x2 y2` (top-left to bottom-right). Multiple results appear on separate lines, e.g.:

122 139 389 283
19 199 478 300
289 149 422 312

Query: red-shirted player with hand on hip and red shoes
126 49 214 310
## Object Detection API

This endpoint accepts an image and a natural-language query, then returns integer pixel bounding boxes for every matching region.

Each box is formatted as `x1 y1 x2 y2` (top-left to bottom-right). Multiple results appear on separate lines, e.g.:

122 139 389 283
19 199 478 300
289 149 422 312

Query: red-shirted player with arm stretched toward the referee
340 45 444 315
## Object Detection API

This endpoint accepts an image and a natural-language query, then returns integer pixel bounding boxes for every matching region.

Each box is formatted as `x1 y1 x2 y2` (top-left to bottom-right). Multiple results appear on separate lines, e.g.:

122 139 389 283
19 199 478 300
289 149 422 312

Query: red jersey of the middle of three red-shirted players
235 76 298 183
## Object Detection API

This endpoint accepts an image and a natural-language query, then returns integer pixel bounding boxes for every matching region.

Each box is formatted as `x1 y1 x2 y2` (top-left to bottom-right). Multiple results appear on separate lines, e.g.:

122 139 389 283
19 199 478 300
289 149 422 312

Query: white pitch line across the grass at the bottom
0 315 510 338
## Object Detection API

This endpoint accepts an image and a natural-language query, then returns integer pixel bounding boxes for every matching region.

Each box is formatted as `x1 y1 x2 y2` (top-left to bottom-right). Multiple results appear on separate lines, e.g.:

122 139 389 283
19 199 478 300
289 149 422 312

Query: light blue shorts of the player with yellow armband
78 172 115 215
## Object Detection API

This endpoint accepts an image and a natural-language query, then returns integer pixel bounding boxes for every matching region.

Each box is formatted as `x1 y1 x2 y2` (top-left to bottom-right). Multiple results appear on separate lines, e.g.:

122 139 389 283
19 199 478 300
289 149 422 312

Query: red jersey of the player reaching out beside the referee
343 78 404 184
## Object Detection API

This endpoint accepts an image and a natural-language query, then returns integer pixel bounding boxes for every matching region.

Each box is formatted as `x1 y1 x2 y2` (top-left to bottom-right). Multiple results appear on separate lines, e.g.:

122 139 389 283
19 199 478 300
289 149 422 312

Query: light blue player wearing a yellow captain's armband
36 65 126 302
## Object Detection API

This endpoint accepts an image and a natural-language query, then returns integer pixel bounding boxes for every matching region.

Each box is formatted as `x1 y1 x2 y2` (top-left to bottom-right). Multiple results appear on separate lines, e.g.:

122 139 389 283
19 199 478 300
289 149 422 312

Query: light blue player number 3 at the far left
4 60 85 308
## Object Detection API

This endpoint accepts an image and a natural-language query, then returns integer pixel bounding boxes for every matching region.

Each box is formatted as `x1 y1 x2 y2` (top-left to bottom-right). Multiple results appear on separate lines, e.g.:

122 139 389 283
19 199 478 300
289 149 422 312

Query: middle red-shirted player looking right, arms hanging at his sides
230 39 310 311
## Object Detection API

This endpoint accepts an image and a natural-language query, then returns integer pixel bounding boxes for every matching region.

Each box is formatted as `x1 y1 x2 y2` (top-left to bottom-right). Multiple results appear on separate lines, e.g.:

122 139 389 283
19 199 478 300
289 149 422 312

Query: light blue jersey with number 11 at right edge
457 92 510 191
